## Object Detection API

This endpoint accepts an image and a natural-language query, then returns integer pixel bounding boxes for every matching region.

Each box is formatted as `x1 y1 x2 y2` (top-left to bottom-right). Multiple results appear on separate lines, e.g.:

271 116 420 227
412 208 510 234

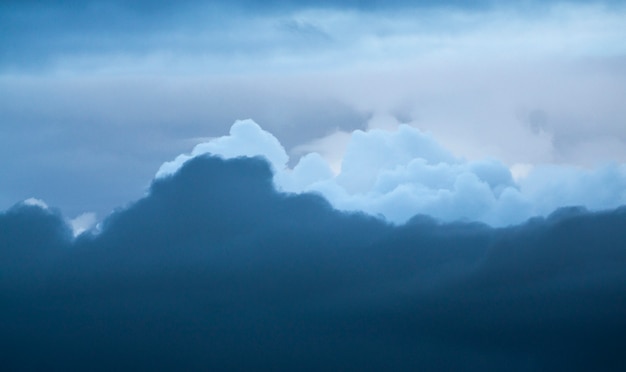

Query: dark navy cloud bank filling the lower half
0 157 626 371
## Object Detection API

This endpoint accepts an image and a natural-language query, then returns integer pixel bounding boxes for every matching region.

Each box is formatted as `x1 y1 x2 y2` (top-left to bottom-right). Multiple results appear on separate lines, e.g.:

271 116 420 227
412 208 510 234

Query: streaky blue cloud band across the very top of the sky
0 0 623 75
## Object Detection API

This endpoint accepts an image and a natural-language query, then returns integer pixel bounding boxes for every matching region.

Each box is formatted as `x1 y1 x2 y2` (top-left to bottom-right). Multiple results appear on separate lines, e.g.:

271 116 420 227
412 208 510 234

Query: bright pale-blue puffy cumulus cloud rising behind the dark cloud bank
157 120 626 226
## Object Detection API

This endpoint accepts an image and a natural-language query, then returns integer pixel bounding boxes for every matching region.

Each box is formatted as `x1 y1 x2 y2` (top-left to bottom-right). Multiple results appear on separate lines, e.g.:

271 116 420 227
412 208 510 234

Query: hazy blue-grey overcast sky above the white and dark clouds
0 0 626 224
